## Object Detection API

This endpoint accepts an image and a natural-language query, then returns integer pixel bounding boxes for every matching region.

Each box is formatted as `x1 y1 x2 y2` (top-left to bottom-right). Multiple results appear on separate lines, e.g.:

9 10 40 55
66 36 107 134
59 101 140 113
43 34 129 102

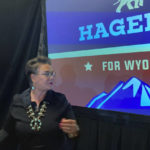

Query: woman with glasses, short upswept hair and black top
0 56 79 150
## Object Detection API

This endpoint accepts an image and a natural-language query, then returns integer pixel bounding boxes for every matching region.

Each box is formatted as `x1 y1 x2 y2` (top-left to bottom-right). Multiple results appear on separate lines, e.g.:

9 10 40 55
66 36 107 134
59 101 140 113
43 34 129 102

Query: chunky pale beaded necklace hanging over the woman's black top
27 102 47 132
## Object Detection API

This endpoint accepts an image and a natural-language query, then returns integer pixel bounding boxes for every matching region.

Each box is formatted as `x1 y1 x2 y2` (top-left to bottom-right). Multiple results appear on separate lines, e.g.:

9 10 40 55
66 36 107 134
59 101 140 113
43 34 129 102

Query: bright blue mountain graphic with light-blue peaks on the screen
86 77 150 114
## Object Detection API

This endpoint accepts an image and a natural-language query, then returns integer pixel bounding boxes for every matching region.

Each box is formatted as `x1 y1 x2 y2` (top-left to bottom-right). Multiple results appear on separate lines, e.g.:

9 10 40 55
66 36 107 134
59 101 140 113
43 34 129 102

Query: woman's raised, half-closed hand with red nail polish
59 118 79 138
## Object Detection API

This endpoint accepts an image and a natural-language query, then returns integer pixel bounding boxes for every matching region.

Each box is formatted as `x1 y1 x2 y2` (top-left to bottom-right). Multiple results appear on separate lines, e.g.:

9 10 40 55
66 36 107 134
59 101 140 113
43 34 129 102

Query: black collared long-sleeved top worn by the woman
0 89 75 150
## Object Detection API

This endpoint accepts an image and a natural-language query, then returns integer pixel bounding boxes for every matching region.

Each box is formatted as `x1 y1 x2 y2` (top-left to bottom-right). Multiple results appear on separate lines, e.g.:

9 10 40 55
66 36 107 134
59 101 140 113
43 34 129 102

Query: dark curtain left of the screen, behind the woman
0 0 47 125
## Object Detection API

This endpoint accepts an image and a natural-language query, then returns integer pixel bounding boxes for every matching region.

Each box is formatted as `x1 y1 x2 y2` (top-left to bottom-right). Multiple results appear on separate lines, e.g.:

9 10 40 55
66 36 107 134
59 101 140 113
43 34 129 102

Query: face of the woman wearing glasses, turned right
31 64 55 91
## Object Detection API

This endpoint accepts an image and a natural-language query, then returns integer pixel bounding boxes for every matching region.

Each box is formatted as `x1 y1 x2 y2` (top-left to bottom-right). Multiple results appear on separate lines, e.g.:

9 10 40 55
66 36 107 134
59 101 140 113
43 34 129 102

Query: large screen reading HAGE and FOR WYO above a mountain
47 0 150 115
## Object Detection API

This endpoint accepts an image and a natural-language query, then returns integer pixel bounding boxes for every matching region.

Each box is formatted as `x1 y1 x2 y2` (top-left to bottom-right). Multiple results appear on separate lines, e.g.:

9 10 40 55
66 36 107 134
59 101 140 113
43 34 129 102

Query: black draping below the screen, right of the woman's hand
73 106 150 150
